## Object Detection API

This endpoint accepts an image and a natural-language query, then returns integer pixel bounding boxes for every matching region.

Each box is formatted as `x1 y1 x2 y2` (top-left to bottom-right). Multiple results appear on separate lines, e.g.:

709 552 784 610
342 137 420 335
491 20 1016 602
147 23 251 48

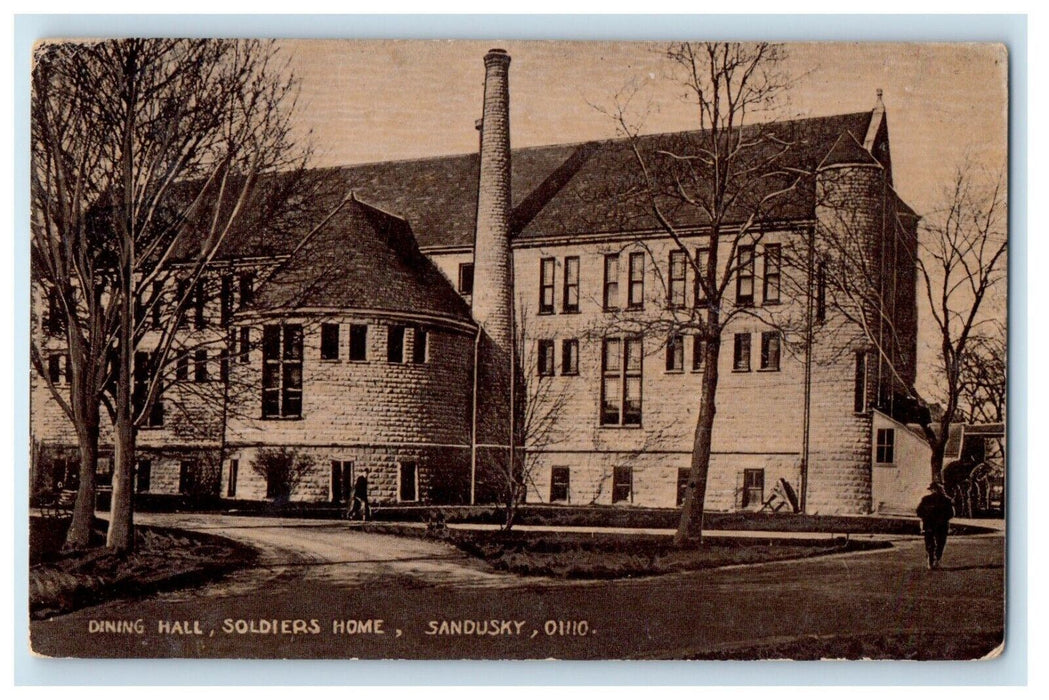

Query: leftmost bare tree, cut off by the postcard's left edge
30 44 116 547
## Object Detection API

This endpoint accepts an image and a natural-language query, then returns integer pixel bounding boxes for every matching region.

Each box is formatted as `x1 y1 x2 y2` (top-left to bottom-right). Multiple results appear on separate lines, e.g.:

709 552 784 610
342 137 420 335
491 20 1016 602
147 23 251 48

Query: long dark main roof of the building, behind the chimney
178 111 877 259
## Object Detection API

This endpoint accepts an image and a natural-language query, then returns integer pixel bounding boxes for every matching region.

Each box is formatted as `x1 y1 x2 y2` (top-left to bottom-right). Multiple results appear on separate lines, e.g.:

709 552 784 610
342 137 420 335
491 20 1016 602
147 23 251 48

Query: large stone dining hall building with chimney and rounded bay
26 49 917 513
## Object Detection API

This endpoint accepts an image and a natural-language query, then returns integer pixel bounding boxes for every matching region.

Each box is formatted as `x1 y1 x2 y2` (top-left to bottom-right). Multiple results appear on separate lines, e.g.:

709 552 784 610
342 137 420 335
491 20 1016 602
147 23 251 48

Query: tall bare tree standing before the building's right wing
609 43 811 546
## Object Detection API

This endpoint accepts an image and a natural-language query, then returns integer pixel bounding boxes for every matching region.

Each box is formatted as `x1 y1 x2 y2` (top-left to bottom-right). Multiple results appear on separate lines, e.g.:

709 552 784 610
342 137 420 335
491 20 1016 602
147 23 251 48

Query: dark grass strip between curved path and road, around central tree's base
368 524 890 578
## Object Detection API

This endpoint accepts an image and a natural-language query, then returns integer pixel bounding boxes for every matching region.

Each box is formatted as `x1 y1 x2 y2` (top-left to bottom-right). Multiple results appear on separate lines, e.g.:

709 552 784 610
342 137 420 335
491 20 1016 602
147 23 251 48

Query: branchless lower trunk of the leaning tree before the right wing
673 333 721 547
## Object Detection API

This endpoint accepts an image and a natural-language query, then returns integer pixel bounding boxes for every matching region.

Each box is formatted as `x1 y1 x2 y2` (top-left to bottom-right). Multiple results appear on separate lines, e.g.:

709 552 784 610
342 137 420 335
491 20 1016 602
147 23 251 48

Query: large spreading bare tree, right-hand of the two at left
32 39 304 551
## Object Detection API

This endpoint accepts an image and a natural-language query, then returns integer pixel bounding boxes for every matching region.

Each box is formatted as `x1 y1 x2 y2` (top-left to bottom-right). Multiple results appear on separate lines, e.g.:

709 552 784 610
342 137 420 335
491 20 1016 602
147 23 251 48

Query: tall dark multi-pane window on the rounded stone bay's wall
262 324 302 418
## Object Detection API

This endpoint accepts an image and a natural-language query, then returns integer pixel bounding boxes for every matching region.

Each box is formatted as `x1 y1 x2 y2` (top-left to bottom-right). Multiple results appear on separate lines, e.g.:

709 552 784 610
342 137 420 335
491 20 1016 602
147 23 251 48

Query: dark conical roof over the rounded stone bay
251 196 472 323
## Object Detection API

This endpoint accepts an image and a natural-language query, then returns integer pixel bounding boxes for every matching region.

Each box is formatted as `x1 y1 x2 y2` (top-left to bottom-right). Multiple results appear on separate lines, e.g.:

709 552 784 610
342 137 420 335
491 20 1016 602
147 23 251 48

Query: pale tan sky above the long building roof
281 40 1008 402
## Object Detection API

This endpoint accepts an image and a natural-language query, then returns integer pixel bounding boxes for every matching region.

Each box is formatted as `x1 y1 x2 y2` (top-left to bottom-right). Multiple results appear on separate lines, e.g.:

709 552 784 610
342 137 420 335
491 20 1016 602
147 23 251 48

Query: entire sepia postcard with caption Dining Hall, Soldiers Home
24 38 1009 661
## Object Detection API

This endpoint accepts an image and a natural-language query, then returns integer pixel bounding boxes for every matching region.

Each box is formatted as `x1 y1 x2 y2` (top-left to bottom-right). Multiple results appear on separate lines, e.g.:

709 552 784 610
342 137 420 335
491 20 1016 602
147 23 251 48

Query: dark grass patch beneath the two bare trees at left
29 517 255 619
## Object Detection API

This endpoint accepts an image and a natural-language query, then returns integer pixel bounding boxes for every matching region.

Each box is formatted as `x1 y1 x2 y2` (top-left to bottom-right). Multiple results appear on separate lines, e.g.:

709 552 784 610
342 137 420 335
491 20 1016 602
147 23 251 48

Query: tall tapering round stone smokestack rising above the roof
472 48 514 353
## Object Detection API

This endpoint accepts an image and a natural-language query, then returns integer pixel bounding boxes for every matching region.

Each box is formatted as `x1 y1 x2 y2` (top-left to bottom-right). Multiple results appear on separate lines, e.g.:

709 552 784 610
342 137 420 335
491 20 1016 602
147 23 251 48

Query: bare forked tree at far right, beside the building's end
814 165 1007 479
